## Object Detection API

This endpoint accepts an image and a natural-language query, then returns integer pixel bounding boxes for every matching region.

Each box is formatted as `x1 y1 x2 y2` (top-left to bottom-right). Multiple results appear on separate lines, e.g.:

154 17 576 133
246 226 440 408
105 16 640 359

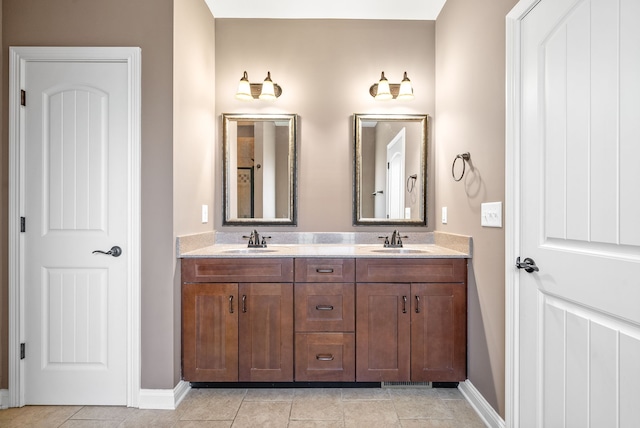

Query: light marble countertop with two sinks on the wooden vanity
180 244 470 258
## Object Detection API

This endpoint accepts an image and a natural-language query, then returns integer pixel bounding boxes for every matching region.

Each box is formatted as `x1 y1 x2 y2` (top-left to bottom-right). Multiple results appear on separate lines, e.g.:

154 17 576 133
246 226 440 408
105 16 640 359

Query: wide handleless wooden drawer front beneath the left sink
182 258 293 282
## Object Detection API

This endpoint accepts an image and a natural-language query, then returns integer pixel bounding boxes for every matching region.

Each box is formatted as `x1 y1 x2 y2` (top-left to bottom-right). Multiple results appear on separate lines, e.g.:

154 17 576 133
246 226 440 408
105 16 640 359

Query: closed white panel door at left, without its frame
23 61 130 405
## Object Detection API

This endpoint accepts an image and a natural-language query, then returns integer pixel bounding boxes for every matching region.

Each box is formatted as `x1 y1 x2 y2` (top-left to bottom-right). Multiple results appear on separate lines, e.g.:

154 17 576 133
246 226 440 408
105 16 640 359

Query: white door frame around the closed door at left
9 47 141 407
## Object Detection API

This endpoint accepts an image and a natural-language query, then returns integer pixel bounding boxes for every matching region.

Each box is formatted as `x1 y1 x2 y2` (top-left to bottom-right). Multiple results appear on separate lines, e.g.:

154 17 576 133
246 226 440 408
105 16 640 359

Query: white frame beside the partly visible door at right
505 0 540 427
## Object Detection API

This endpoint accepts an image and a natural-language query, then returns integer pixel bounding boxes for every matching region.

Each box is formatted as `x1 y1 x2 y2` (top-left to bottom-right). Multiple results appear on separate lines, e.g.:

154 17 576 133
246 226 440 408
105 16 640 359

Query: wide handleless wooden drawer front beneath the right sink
356 258 467 283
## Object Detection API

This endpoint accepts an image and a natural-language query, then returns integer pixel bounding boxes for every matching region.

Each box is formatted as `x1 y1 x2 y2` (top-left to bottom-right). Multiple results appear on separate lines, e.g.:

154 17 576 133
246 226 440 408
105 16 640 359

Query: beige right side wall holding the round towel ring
435 0 517 417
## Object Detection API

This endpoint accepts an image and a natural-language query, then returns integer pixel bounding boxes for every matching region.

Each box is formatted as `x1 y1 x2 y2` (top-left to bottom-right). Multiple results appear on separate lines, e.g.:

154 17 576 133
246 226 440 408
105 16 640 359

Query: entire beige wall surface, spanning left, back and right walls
0 0 516 416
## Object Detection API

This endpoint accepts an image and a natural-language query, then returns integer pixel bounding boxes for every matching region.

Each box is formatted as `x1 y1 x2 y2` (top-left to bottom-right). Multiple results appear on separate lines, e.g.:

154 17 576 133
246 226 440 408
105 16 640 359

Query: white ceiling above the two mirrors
205 0 446 20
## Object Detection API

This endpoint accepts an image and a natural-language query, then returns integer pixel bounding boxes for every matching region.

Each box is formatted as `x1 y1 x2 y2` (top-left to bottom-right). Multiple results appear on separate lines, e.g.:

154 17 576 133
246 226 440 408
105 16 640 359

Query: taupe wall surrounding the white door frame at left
0 0 180 388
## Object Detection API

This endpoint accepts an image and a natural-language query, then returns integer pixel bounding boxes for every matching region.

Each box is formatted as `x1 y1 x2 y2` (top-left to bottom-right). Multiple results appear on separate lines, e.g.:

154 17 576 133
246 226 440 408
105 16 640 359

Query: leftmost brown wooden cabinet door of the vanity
182 283 238 382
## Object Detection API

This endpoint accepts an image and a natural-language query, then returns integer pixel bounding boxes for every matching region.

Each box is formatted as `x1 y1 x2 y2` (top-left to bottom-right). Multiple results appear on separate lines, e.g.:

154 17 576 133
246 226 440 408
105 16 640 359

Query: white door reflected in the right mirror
387 128 405 218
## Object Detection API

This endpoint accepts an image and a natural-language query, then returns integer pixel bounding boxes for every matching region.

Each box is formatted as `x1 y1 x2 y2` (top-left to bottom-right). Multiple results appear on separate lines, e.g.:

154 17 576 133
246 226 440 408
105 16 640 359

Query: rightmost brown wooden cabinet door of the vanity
411 283 467 382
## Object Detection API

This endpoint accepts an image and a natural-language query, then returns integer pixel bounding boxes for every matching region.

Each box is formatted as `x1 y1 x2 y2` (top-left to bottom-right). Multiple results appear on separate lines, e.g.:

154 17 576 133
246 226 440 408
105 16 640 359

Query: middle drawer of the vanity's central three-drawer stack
294 283 355 331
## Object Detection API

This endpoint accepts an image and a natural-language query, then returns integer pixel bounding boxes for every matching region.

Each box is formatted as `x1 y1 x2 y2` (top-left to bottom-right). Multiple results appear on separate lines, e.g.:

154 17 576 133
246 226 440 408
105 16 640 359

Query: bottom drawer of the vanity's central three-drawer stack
295 333 355 382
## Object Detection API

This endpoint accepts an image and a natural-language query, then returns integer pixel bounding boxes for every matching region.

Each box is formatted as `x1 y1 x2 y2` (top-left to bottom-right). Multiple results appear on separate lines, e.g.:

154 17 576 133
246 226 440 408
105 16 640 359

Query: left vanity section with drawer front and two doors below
182 258 293 382
